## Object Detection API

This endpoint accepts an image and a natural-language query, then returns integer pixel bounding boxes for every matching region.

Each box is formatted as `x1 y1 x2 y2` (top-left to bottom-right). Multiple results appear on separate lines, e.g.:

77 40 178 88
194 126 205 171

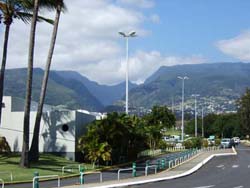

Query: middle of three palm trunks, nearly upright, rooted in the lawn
20 0 39 168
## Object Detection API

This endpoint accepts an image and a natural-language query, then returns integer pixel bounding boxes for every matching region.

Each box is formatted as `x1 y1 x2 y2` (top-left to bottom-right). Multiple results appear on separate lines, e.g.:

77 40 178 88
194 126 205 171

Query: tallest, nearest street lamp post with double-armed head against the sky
118 31 136 114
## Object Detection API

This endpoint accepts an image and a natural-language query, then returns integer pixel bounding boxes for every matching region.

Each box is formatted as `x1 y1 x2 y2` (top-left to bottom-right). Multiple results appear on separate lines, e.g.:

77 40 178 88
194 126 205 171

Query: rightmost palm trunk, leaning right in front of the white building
30 3 62 162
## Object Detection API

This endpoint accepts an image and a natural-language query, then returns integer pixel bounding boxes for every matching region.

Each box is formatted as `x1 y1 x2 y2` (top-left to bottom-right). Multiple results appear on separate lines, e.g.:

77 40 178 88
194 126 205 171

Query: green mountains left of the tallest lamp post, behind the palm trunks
4 68 137 111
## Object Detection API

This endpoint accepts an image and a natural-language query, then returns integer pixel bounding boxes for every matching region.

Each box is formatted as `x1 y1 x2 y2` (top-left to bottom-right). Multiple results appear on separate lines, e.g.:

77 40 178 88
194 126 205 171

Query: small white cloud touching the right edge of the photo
216 30 250 61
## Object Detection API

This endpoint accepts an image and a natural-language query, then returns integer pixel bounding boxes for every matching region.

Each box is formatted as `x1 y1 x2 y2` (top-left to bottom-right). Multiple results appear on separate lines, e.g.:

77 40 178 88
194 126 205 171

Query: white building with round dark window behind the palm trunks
0 96 96 161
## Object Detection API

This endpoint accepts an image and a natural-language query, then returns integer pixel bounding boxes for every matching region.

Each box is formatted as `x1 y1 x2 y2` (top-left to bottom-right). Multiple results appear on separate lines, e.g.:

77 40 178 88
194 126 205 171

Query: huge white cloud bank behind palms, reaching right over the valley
0 0 204 84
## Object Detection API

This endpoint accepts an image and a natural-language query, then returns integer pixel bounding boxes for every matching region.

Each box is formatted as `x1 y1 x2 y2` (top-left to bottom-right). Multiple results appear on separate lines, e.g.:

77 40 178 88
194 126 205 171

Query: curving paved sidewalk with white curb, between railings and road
61 148 237 188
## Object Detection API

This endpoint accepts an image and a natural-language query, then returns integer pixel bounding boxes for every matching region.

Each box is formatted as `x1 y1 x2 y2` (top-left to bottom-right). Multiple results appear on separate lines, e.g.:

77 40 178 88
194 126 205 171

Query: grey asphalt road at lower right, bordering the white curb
130 145 250 188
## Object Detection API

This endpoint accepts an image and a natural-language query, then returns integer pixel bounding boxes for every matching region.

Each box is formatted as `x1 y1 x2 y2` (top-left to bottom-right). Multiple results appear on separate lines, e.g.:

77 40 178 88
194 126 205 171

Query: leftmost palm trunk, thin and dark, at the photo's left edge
0 24 10 126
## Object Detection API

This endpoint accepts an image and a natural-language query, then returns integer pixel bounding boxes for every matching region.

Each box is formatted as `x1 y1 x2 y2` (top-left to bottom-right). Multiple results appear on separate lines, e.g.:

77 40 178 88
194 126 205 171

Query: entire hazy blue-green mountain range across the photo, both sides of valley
4 63 250 111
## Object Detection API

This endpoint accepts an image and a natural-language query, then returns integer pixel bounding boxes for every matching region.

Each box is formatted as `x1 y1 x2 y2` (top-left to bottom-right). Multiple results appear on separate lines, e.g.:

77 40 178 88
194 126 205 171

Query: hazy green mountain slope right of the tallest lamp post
130 63 250 107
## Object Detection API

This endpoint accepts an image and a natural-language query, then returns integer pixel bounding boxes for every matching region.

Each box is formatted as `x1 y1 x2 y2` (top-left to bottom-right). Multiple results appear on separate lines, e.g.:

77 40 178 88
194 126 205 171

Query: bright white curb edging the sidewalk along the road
89 150 237 188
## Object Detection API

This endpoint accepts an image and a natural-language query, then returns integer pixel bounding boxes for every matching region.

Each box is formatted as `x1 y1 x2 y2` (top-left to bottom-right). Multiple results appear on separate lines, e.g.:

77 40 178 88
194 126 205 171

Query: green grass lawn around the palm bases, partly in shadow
0 154 95 182
